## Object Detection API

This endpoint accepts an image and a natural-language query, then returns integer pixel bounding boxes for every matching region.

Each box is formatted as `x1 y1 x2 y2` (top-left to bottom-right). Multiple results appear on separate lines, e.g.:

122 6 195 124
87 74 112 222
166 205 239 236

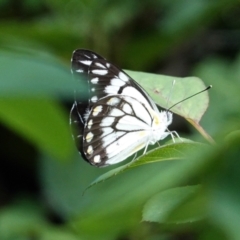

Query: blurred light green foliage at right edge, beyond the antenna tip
193 54 240 137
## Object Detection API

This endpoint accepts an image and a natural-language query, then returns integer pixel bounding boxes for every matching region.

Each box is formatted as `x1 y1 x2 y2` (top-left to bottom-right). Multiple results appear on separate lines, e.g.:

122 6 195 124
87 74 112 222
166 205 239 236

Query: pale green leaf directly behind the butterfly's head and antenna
127 71 209 122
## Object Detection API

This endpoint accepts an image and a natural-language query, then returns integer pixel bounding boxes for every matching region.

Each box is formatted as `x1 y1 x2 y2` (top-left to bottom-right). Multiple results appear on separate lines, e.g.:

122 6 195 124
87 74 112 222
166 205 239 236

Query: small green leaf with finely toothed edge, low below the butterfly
142 186 203 223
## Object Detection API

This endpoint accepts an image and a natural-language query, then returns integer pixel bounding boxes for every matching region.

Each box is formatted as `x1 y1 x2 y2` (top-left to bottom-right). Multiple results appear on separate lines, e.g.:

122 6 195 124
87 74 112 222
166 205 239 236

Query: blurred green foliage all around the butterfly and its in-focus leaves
0 0 240 240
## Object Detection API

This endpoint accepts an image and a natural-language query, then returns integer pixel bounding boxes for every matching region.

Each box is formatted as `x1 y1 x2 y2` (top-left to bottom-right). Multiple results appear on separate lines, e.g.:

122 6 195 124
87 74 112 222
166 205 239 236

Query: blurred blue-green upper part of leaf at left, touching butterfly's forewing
0 49 74 98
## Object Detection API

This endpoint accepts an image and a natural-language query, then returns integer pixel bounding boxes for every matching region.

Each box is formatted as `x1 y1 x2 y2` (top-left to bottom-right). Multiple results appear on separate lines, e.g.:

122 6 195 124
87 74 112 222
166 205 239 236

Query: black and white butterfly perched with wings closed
70 49 174 167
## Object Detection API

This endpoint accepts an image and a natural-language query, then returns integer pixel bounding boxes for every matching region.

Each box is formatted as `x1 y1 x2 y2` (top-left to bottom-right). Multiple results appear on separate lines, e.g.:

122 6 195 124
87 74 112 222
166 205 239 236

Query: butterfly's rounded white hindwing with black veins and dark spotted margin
83 95 152 167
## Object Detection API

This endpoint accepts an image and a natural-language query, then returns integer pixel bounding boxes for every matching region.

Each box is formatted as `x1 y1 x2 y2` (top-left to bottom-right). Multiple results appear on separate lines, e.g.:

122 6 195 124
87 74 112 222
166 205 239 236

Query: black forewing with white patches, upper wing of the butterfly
72 49 156 111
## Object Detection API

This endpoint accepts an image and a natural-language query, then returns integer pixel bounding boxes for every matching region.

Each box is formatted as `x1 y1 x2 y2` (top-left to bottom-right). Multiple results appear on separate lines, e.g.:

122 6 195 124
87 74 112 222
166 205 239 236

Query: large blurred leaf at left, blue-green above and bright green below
0 49 74 159
